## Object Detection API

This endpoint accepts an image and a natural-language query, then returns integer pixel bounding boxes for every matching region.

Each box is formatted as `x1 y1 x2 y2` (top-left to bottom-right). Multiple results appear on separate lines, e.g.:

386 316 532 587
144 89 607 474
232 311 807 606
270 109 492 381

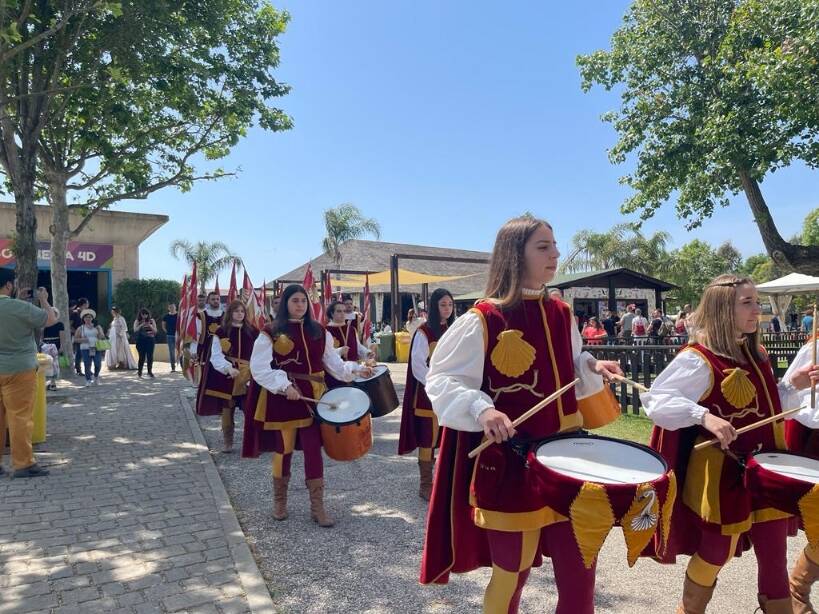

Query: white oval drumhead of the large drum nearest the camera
536 437 666 484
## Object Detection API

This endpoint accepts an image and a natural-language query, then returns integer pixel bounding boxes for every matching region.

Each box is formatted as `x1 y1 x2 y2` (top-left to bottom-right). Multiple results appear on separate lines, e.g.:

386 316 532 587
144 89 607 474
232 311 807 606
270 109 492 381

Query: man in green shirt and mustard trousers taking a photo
0 269 57 478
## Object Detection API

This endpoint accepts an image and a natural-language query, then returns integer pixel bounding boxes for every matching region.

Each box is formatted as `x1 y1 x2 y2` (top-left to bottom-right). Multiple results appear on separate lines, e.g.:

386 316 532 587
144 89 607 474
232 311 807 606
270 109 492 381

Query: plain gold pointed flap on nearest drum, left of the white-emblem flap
569 482 615 569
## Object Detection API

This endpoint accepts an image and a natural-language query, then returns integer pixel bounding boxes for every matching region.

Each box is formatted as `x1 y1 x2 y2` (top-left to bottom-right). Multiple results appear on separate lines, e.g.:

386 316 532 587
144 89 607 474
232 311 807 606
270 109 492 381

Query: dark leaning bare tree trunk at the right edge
739 170 819 275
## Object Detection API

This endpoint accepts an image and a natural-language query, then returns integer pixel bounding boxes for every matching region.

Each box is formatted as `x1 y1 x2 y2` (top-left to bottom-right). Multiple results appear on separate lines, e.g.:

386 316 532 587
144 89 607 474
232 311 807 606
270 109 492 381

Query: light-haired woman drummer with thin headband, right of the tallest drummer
641 275 812 613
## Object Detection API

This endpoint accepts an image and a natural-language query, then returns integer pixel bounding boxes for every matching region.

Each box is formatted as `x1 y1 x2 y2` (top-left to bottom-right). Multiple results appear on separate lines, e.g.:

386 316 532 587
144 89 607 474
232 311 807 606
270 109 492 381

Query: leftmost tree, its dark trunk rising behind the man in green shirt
0 0 119 288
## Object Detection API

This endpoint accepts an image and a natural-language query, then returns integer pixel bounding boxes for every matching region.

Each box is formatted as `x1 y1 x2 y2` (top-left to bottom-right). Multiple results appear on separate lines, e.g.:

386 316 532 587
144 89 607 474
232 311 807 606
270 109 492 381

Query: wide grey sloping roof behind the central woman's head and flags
277 239 491 295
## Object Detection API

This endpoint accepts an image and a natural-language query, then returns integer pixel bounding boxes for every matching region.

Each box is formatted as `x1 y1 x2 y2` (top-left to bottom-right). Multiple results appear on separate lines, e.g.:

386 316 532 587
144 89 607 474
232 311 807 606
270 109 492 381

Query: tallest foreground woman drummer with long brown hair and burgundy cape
421 216 620 614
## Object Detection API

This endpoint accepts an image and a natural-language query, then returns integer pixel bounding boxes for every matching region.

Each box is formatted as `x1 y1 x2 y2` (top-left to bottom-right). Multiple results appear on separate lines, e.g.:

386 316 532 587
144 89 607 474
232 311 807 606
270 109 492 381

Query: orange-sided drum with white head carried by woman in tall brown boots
316 387 373 461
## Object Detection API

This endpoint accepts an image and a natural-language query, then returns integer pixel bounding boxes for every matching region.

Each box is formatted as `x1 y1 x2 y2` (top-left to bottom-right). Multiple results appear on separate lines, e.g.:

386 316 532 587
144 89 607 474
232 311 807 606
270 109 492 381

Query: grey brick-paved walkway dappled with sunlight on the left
0 365 273 614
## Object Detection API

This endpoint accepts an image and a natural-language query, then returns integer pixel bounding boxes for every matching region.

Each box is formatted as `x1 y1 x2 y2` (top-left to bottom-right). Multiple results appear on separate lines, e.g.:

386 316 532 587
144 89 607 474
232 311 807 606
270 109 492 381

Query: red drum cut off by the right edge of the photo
745 451 819 546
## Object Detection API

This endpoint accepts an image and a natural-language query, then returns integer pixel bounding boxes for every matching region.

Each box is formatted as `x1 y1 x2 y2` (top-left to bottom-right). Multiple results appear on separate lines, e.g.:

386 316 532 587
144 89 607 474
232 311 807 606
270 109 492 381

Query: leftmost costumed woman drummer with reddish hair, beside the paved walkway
196 300 259 452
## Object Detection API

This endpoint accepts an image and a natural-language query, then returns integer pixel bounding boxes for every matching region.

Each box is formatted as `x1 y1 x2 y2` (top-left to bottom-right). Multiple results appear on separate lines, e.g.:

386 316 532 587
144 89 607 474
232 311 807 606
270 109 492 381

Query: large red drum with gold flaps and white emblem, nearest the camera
528 433 677 568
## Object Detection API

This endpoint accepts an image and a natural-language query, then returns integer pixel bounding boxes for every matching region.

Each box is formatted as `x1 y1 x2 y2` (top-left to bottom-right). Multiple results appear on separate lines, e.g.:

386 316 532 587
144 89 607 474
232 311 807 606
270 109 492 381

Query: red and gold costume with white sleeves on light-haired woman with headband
641 343 812 607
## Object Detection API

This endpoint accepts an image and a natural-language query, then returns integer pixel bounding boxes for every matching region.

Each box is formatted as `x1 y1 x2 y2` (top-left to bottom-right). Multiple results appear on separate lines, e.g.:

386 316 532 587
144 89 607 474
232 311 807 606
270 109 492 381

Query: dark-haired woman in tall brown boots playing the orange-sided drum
242 285 372 527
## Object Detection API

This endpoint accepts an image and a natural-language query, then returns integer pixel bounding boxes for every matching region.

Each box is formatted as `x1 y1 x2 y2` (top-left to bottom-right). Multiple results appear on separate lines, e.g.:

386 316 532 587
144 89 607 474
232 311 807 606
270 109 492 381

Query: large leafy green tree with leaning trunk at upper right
578 0 819 274
